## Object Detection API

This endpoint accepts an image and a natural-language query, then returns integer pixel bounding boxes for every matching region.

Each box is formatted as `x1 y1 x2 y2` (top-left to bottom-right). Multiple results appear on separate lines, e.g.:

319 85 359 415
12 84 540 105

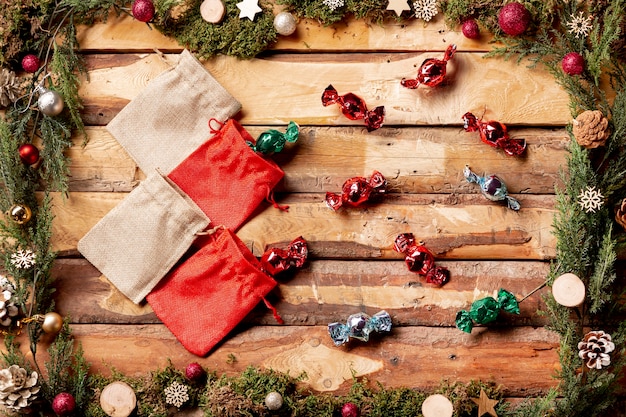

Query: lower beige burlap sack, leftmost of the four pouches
78 172 209 303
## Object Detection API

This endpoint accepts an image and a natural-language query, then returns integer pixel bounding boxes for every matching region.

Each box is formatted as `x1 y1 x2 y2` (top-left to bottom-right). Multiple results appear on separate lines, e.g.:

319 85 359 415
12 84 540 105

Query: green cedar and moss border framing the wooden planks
0 0 626 417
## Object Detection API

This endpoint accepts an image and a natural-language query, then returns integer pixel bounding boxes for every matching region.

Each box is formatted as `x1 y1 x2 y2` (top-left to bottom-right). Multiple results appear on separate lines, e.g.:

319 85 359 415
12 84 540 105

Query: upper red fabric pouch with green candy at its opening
167 119 286 231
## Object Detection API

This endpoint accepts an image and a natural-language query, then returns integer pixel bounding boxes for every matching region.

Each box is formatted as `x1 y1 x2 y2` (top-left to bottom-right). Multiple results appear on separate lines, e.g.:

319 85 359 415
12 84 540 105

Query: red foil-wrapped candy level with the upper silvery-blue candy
325 171 387 210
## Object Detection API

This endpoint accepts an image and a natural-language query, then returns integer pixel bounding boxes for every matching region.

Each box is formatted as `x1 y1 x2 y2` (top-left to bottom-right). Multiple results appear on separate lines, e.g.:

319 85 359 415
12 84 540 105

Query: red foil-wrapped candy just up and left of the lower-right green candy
393 233 450 286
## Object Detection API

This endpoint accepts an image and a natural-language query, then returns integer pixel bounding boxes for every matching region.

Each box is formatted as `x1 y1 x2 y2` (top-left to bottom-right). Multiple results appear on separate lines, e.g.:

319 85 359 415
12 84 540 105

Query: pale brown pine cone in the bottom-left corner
0 365 41 412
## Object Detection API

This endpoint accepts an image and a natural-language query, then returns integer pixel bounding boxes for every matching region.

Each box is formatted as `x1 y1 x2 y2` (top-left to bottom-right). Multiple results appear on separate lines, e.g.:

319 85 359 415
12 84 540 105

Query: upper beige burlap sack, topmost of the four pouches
107 50 241 174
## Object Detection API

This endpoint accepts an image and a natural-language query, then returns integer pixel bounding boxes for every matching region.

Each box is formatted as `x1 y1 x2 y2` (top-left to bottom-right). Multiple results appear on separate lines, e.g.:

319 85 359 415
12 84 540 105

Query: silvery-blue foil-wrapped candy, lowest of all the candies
328 310 391 346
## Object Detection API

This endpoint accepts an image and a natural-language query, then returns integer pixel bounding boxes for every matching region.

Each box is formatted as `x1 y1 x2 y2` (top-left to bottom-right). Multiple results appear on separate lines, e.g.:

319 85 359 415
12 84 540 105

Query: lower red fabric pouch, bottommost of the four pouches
146 228 280 356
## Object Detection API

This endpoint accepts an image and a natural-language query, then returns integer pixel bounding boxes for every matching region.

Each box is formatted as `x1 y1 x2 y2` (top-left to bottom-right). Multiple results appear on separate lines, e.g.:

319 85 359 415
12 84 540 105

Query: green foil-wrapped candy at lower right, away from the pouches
455 288 520 333
